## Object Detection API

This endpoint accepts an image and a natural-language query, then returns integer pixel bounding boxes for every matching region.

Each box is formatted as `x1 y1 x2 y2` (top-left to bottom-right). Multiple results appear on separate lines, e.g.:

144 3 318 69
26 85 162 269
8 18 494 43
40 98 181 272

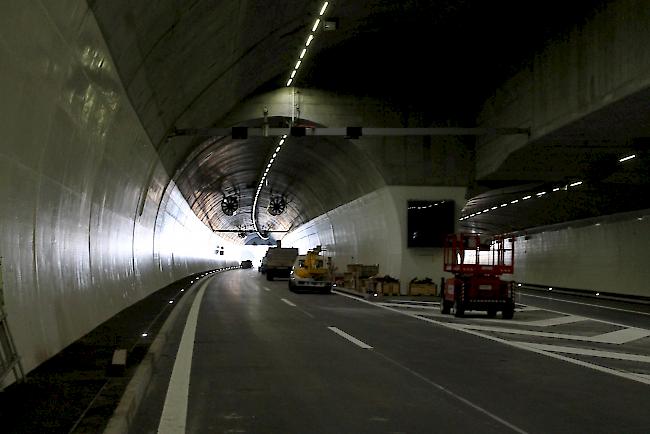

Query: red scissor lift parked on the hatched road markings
440 233 515 319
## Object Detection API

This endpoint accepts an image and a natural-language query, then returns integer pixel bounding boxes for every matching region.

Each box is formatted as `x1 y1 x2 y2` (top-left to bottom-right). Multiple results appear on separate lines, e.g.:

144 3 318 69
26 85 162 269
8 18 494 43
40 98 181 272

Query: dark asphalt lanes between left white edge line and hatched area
133 270 650 433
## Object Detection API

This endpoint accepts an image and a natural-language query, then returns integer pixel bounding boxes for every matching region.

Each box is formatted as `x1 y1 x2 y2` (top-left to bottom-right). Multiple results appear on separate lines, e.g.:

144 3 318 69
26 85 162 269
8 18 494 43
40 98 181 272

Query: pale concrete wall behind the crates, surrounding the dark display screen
282 186 465 293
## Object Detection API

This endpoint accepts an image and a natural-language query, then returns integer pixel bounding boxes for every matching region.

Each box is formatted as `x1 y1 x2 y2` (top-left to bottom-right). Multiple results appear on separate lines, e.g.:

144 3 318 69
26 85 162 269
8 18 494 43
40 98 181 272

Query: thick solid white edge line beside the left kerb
158 280 210 434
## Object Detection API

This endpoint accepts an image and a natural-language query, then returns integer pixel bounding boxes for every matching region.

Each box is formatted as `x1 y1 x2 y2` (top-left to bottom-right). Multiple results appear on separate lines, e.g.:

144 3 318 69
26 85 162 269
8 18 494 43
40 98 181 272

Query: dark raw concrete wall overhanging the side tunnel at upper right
477 0 650 179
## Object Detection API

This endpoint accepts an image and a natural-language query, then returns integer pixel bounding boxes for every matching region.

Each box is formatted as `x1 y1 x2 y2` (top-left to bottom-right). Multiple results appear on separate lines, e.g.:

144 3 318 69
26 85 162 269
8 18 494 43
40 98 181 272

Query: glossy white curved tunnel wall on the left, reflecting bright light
0 0 238 381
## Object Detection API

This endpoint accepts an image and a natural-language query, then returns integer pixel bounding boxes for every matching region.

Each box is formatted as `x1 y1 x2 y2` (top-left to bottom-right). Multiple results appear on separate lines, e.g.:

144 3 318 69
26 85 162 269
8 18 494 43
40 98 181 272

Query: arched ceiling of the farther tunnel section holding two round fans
176 117 383 242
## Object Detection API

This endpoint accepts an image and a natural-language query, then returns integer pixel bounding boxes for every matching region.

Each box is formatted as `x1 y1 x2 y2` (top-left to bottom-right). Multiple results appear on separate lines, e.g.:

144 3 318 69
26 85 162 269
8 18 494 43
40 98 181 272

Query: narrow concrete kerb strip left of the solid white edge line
104 276 212 434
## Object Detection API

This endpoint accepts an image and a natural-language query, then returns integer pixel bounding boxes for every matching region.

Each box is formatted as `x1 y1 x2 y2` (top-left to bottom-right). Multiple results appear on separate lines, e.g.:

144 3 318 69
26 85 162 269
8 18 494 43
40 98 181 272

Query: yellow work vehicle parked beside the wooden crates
289 246 332 293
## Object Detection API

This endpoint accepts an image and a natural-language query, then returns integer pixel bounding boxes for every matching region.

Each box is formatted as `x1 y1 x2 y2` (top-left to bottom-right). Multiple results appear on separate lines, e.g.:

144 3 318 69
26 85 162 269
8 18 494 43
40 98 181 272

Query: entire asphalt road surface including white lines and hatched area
126 270 650 434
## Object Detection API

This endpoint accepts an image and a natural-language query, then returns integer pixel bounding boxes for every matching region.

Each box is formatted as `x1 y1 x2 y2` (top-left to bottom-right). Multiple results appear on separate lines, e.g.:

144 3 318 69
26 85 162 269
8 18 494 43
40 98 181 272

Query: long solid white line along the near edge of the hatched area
334 291 650 385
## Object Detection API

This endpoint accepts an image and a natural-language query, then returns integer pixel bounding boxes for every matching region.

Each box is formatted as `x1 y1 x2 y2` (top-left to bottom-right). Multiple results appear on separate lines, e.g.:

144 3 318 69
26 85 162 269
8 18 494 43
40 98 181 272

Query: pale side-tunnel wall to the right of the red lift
513 216 650 297
